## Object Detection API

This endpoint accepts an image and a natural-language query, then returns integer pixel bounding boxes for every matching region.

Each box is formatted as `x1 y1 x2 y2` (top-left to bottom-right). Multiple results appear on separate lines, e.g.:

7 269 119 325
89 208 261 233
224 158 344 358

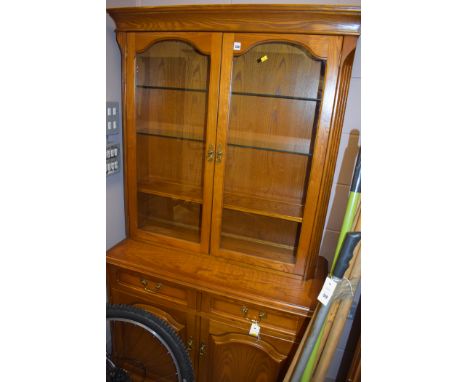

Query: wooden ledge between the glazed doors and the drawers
107 239 323 315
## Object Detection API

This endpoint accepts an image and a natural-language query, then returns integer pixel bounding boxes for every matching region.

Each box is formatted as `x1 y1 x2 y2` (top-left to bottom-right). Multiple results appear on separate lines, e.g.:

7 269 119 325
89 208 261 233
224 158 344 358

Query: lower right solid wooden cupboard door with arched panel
198 319 294 382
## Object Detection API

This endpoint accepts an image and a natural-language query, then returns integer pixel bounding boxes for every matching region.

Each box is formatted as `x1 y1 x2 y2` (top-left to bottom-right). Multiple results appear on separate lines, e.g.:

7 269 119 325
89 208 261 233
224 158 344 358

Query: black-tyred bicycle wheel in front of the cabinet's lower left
106 304 194 382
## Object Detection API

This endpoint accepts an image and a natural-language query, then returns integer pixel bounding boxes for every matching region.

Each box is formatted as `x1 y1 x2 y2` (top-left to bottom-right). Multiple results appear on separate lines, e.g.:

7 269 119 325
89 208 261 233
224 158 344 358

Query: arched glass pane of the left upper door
135 41 209 242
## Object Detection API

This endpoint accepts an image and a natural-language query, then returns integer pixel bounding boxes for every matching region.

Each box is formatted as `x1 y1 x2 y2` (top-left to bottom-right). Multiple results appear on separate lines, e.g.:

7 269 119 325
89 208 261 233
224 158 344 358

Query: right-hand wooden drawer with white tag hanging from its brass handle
202 295 306 336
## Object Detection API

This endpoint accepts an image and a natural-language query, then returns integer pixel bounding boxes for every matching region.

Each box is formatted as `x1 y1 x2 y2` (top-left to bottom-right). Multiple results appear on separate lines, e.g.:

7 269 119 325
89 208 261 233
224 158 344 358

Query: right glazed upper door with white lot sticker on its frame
211 34 342 275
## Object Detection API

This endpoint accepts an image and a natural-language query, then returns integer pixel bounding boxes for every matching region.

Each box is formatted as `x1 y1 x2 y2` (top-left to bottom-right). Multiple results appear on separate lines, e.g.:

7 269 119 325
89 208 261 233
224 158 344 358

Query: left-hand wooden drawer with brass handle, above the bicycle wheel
111 269 197 308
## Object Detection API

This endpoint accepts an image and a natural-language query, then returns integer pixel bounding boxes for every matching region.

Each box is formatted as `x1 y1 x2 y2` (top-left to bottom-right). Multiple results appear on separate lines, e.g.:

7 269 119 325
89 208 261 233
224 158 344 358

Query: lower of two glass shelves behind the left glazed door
136 120 205 143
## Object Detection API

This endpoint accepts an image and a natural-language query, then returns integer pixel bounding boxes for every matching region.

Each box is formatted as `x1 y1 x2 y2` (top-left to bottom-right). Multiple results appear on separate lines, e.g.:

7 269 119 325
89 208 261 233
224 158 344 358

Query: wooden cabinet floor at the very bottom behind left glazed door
138 217 200 243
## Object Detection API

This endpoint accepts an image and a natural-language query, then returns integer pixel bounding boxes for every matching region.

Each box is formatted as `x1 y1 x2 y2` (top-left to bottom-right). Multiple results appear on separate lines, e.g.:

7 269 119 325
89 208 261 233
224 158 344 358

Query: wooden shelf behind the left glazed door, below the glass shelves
138 179 203 204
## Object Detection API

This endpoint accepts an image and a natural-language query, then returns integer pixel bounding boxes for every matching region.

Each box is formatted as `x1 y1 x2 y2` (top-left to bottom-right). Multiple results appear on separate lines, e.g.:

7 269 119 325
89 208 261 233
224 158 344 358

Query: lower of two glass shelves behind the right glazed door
228 130 312 156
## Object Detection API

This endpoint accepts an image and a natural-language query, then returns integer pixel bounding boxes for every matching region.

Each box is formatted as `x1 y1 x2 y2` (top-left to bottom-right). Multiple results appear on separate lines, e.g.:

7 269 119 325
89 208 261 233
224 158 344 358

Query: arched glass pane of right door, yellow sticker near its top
221 42 325 263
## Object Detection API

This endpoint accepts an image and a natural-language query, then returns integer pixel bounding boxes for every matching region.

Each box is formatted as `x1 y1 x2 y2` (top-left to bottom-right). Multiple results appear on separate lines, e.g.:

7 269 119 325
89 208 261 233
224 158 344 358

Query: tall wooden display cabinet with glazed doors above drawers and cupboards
107 5 360 381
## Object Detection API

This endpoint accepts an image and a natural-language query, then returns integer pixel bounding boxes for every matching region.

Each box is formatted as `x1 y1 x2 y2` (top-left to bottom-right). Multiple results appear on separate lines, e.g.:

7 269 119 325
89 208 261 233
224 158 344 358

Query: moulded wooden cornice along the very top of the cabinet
107 4 361 35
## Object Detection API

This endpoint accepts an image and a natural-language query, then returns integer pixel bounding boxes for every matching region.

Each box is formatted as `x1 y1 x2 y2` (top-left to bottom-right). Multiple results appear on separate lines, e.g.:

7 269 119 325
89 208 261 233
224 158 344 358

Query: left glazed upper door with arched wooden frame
121 32 221 253
